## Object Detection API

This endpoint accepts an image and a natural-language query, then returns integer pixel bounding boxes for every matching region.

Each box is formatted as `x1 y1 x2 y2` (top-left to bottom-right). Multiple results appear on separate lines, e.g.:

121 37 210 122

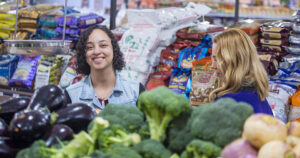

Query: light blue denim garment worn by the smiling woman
66 72 140 110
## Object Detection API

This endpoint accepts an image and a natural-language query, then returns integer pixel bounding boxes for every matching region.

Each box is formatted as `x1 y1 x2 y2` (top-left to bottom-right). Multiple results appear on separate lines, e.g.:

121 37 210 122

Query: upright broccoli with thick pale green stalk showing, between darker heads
138 87 190 142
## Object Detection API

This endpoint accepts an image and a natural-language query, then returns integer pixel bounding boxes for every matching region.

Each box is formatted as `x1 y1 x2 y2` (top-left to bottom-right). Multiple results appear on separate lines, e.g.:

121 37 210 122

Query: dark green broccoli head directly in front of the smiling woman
97 104 144 132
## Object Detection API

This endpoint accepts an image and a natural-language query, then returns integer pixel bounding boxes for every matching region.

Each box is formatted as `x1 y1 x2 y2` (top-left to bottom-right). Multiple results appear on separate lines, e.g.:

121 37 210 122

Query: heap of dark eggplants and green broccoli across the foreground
0 85 253 158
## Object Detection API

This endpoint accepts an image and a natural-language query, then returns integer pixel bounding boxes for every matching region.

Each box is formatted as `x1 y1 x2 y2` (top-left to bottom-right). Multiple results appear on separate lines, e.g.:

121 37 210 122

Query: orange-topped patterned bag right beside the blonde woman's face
190 57 218 106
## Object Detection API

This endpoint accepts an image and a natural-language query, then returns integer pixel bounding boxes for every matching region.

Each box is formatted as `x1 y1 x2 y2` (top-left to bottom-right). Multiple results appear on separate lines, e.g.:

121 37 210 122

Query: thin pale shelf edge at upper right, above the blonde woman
205 13 292 20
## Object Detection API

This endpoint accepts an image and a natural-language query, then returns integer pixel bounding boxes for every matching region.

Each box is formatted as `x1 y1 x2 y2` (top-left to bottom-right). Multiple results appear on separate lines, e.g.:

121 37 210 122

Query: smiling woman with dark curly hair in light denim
66 25 144 111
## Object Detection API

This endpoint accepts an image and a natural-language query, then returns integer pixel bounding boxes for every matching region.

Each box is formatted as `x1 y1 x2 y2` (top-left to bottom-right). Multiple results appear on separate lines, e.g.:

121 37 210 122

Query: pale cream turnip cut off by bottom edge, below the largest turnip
258 140 296 158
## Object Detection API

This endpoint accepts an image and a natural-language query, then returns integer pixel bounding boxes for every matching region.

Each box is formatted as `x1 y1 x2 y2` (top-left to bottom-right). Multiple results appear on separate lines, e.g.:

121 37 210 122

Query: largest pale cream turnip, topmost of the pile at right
243 114 287 149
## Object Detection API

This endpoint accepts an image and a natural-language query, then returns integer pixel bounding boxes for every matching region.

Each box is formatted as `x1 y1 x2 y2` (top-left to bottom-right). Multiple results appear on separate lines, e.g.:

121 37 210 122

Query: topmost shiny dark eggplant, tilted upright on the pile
27 85 67 112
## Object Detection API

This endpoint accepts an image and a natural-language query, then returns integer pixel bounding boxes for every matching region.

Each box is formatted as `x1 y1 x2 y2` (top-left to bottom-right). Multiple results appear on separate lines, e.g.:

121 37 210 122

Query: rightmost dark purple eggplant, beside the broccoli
55 103 96 133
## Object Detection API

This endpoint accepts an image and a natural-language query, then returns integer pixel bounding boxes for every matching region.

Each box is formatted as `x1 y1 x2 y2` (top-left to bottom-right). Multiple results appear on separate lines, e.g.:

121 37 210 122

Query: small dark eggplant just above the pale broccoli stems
43 124 74 147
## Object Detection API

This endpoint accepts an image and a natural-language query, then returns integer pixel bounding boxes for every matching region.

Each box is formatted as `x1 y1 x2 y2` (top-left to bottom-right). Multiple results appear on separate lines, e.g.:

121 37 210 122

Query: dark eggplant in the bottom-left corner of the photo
0 137 21 158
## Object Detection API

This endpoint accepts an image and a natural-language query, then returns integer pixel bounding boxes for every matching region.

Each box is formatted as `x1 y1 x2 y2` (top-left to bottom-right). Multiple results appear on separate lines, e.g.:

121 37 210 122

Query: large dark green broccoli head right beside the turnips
188 98 253 147
